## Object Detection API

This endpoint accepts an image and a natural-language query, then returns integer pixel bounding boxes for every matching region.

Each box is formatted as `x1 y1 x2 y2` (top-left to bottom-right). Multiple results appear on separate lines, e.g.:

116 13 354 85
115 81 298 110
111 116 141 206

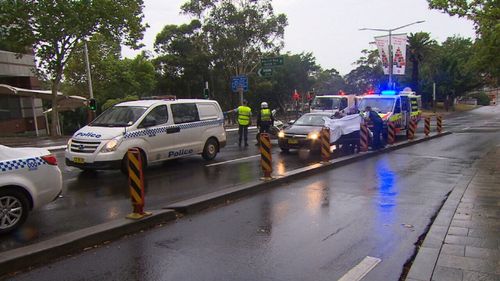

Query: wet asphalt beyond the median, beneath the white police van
0 130 319 252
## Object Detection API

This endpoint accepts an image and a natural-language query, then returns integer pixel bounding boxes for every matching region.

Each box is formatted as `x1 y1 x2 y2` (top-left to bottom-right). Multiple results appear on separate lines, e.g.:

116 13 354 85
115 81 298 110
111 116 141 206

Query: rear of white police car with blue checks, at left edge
0 145 62 234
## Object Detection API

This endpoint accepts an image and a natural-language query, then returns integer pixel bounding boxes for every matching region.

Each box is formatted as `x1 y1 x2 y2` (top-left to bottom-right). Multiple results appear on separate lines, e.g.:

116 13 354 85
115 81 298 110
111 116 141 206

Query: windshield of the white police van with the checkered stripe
89 106 148 127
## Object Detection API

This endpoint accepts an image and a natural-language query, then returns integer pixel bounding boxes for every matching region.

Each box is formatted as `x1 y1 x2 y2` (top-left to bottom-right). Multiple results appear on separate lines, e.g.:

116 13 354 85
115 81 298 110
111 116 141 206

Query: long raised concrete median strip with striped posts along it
0 132 451 275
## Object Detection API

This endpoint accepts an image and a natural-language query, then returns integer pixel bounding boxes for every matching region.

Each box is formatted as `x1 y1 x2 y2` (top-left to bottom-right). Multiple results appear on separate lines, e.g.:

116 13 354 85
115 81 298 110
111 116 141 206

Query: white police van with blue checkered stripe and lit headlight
65 99 226 170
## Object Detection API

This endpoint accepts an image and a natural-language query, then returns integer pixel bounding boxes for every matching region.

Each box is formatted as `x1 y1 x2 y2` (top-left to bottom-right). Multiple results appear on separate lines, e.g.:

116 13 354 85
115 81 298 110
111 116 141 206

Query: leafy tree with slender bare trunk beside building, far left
0 0 146 135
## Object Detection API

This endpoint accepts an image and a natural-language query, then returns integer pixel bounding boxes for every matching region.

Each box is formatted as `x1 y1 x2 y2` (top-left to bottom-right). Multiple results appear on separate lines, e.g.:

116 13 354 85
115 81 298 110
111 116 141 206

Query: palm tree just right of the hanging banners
408 32 437 101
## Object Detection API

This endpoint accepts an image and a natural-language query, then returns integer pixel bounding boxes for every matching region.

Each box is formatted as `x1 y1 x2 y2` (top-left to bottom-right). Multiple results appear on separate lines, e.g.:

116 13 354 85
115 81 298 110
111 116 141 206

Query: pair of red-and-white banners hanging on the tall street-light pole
375 34 406 75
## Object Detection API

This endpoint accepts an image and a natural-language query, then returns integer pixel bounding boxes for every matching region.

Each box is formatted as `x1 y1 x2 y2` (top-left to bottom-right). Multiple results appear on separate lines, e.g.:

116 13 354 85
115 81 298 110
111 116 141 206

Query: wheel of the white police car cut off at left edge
0 188 29 234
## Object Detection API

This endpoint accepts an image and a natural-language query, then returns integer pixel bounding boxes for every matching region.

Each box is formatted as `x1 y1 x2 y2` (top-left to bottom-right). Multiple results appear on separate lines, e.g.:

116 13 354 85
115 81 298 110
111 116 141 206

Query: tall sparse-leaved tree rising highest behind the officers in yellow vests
181 0 287 106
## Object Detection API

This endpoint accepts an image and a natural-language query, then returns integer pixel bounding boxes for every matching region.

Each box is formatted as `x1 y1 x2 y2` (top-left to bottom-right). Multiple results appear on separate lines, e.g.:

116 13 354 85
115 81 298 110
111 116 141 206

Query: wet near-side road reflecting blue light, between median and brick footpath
6 107 500 280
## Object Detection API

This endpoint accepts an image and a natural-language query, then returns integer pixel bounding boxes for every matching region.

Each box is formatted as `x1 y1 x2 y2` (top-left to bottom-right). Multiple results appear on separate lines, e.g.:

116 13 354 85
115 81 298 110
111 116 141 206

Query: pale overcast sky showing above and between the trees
123 0 475 74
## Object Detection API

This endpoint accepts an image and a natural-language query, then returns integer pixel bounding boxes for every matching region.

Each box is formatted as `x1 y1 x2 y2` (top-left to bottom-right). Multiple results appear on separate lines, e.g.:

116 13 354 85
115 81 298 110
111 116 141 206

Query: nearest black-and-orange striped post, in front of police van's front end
127 148 151 220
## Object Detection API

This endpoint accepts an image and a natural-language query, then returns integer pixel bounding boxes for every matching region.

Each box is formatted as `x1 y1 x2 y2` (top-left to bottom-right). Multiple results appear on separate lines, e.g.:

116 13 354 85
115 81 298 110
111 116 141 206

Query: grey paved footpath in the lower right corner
406 144 500 281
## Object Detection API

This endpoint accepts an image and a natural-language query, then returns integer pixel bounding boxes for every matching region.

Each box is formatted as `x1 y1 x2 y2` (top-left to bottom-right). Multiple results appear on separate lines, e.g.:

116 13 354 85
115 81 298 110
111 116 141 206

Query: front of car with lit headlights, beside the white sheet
278 112 334 152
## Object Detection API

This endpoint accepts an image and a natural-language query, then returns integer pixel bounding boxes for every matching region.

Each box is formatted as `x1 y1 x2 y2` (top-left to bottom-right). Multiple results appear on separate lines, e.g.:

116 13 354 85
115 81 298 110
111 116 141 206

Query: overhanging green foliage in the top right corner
427 0 500 86
